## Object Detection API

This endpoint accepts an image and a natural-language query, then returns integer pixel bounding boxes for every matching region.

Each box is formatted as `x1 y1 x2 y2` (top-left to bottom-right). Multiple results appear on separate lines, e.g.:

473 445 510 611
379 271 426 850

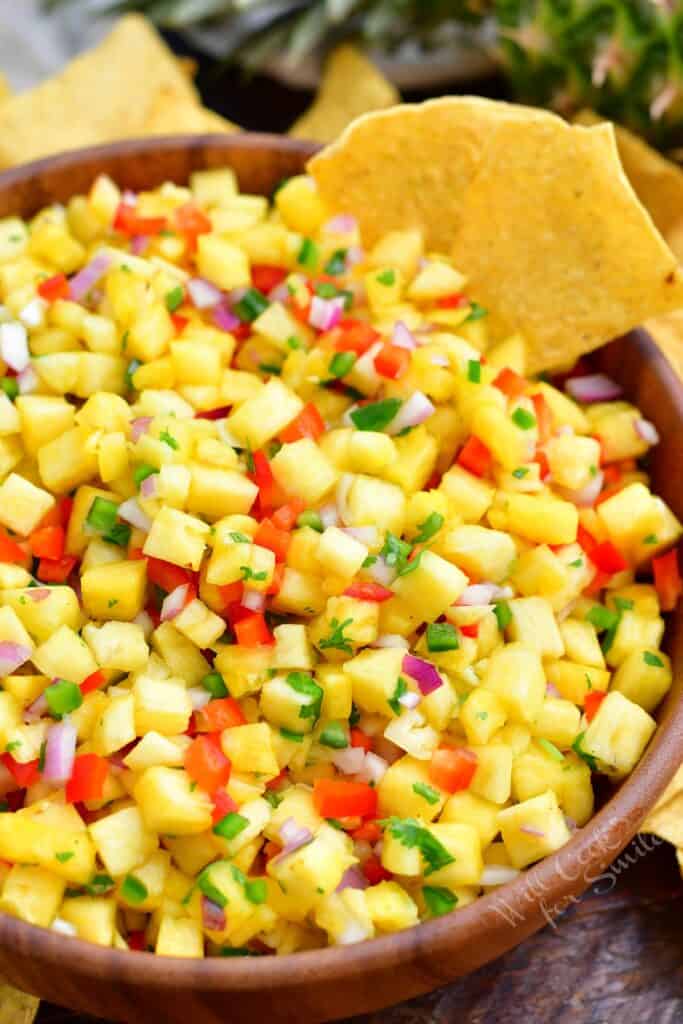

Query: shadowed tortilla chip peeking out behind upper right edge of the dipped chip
574 111 683 263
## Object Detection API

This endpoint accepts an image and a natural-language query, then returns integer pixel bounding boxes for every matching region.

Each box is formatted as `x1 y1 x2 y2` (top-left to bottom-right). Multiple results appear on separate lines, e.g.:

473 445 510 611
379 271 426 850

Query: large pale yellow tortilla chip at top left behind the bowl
0 14 198 168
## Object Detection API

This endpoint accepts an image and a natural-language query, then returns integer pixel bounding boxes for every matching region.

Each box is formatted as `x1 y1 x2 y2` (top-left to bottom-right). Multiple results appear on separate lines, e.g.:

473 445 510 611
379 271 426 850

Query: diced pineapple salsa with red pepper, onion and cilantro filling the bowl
0 161 681 957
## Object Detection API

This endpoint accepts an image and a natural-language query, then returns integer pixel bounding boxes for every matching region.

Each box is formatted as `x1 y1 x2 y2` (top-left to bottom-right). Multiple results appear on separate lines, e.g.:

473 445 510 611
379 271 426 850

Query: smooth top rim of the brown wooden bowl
0 132 683 992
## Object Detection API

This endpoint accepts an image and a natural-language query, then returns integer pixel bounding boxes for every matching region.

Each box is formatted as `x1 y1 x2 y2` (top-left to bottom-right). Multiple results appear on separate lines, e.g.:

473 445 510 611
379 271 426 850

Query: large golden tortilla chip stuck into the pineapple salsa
309 97 683 373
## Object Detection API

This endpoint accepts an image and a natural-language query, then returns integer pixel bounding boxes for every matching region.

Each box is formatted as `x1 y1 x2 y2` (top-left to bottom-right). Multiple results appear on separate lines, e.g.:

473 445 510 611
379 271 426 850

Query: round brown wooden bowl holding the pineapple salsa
0 135 683 1024
